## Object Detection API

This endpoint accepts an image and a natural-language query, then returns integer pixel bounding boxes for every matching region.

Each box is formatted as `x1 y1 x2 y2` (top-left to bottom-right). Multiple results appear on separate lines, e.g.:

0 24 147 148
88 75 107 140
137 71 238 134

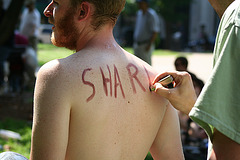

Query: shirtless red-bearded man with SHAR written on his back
30 0 183 160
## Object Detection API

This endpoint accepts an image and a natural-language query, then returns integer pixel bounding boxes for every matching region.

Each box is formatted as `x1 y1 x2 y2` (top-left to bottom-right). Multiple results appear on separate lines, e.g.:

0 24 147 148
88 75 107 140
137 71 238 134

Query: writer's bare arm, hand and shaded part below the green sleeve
153 72 240 160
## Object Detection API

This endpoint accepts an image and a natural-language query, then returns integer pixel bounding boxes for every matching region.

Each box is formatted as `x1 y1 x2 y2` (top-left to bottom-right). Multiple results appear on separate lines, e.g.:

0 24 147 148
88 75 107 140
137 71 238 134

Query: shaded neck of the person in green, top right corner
208 0 234 18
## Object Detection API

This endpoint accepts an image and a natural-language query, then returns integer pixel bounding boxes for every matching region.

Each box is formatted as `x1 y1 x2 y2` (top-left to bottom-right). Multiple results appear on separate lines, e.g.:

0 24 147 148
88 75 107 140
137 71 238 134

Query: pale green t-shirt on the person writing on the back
189 0 240 144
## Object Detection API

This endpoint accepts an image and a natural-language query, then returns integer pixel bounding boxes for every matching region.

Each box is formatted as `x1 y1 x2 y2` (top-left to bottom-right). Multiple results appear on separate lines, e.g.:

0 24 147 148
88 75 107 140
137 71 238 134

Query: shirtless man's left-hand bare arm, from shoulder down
30 61 70 160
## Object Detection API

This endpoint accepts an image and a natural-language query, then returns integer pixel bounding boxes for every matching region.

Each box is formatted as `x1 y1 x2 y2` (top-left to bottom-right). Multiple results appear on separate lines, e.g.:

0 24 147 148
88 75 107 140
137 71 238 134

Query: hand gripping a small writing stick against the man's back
153 72 197 115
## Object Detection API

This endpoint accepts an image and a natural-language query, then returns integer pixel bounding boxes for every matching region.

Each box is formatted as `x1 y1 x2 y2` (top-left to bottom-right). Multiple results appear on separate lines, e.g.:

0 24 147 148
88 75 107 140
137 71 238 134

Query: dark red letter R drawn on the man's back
127 63 146 93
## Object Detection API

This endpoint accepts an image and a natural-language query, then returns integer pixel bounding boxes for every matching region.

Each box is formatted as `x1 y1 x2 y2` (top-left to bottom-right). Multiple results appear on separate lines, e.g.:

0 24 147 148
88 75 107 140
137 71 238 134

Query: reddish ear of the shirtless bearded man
78 2 91 21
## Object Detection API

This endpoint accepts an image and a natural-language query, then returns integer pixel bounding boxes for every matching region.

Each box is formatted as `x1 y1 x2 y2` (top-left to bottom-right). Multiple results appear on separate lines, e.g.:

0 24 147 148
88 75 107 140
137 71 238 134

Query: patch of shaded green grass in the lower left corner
0 119 32 158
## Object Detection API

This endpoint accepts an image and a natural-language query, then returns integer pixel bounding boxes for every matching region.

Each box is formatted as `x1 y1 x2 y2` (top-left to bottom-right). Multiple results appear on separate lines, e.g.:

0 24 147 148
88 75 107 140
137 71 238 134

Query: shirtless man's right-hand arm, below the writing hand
150 103 184 160
